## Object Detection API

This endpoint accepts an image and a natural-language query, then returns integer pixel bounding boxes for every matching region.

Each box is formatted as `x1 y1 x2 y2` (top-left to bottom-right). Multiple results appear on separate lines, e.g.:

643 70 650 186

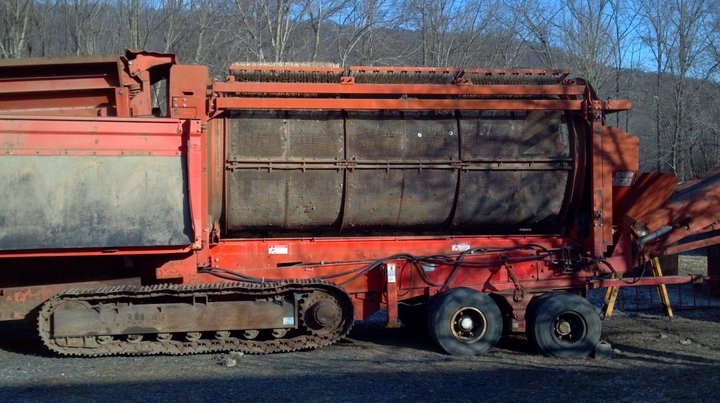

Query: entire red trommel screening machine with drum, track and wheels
0 52 718 356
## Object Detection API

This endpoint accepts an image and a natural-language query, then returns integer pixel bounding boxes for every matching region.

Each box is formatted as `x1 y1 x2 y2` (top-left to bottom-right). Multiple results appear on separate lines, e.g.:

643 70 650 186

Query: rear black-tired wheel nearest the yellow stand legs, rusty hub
527 292 602 357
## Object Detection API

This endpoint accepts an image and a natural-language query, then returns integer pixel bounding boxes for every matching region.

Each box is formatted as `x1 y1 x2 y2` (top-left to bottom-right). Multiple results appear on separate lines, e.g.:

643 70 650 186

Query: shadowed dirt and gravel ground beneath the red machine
0 258 720 401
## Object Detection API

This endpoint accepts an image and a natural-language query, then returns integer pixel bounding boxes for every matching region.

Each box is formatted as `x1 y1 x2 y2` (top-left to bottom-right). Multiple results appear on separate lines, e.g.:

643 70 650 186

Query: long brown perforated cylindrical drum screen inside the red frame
225 111 575 236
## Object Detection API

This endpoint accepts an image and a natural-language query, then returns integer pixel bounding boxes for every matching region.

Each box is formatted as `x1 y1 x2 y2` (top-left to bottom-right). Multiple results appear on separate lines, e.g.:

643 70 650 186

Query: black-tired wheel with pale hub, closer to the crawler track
428 288 503 355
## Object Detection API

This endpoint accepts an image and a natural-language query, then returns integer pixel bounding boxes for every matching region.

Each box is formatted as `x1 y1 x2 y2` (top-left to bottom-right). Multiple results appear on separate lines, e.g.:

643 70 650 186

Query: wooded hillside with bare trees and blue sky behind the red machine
0 0 720 178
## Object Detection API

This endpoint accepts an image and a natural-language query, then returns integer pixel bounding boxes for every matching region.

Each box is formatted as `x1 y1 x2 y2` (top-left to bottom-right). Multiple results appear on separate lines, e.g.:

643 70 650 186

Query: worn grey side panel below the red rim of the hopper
0 156 192 250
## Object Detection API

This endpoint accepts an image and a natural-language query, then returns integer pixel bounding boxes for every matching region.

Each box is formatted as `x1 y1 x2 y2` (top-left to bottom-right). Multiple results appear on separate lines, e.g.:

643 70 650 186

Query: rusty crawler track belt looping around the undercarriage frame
38 280 354 357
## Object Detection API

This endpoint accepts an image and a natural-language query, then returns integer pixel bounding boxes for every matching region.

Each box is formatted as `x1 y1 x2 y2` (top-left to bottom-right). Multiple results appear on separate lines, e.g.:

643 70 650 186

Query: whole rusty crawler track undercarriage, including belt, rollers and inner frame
38 280 354 356
